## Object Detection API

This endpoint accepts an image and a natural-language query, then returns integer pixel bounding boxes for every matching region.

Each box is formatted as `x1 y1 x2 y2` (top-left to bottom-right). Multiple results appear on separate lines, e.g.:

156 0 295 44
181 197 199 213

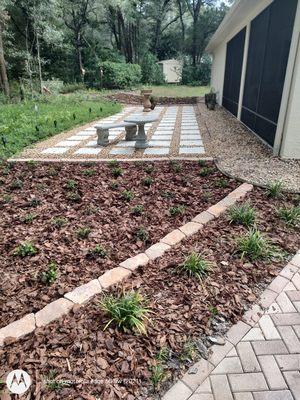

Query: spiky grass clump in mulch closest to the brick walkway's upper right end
237 229 282 261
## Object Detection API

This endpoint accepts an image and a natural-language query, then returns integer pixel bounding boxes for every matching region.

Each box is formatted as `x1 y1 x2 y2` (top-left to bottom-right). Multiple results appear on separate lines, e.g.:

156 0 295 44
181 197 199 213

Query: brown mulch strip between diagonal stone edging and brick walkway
0 189 300 400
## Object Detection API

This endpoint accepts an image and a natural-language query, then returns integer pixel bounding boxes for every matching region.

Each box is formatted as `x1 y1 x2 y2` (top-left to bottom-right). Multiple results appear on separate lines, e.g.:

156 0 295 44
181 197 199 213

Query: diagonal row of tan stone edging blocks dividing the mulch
0 183 253 347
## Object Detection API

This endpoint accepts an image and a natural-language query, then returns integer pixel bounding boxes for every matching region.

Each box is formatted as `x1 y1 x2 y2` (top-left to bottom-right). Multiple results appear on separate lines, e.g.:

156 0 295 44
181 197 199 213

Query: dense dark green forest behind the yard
0 0 230 96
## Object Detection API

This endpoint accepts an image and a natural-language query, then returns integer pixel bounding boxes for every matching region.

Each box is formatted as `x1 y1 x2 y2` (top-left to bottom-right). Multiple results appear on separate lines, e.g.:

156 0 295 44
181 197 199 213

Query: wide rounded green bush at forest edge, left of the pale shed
100 61 142 89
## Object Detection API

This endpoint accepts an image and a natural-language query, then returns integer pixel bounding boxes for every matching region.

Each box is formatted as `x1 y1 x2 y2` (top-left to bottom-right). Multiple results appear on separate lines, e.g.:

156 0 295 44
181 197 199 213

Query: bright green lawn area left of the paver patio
0 95 121 159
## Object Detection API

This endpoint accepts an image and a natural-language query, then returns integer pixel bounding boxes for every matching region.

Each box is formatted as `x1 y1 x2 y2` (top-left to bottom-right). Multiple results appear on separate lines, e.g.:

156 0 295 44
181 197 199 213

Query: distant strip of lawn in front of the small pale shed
139 85 210 97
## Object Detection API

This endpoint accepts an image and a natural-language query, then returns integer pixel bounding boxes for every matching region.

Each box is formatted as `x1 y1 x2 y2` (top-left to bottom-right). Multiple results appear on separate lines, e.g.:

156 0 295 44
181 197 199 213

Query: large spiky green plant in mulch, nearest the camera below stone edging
100 290 151 335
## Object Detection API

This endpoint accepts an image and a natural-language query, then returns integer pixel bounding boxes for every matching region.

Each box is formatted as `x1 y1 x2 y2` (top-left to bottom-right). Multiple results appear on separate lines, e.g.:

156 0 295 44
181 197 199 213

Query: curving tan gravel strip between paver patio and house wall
198 103 300 192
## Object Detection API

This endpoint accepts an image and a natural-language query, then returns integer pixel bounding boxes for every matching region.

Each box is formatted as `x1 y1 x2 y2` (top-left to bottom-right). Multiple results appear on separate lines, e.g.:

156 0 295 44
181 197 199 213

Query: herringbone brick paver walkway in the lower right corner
163 253 300 400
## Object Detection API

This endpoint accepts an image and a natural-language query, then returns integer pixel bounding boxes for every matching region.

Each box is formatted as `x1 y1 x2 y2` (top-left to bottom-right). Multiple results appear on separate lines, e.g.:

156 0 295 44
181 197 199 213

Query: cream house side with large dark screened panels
206 0 300 159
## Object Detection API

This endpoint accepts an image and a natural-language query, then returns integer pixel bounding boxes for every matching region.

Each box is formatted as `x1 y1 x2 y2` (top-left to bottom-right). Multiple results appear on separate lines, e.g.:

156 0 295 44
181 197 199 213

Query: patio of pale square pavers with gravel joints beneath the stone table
12 105 209 161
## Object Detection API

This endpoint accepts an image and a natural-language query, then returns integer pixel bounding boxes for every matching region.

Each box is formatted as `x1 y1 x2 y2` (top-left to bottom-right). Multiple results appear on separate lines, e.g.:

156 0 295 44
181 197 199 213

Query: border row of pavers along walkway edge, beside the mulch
162 250 300 400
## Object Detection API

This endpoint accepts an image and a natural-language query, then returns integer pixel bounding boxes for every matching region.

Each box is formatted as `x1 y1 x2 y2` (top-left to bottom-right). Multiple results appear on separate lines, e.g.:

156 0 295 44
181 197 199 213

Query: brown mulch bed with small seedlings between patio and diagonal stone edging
0 161 238 328
